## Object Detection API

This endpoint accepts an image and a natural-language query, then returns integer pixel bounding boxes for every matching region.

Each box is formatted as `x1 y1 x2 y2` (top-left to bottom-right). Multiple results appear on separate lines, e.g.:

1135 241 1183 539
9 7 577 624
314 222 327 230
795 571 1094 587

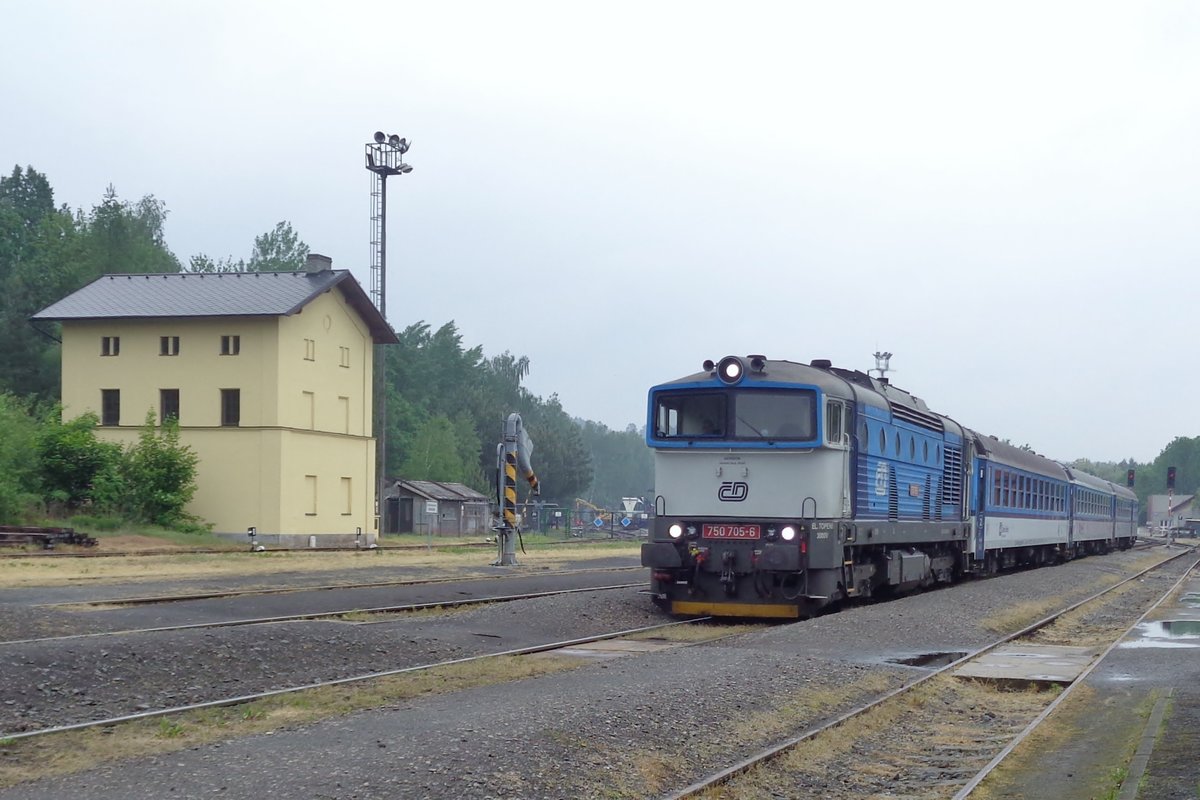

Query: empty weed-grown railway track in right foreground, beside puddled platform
665 551 1200 800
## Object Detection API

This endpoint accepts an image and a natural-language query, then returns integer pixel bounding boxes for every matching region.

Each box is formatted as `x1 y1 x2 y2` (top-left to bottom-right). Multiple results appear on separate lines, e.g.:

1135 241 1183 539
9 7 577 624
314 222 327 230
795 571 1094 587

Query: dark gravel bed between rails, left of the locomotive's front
0 589 664 733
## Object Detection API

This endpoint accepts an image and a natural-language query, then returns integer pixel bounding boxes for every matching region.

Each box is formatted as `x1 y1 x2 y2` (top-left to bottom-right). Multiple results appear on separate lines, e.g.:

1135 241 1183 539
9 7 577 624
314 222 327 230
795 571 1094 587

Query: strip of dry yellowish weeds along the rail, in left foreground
0 656 587 787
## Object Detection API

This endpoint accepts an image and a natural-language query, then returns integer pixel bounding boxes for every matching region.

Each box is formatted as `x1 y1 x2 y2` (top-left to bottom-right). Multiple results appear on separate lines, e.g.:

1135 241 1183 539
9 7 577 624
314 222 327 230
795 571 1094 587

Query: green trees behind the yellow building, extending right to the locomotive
0 166 652 523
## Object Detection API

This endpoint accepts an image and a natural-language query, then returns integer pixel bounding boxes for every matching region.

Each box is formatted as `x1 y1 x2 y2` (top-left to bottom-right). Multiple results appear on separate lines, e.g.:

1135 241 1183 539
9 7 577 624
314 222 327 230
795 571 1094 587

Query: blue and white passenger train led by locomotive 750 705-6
641 355 1138 618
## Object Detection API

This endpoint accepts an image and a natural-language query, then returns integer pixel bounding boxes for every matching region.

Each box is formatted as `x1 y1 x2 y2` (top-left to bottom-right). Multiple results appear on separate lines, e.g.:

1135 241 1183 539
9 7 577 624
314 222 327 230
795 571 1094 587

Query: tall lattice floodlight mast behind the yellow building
366 131 413 536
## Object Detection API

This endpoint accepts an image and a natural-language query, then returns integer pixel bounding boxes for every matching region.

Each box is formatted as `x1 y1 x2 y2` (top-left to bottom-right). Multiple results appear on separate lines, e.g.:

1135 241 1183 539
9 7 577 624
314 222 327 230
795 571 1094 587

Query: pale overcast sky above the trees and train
0 0 1200 461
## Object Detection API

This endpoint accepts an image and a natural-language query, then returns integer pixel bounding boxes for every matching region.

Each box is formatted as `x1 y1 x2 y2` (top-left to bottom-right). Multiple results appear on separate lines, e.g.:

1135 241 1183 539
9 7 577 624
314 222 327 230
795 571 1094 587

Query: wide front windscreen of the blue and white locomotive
654 389 817 441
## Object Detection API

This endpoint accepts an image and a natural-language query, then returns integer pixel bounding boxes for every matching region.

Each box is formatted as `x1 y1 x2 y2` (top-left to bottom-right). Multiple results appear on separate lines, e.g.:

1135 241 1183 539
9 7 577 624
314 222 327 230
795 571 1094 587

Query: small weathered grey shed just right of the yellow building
384 479 491 536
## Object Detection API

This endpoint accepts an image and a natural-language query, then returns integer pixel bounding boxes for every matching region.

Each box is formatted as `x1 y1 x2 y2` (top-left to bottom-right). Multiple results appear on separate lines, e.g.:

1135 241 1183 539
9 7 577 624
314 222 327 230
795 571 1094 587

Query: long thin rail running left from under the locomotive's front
0 616 719 746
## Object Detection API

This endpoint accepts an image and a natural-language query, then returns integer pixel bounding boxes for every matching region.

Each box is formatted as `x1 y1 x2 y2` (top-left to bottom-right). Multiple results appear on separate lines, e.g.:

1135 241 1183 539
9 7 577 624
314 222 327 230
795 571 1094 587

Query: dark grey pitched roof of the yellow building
30 270 398 344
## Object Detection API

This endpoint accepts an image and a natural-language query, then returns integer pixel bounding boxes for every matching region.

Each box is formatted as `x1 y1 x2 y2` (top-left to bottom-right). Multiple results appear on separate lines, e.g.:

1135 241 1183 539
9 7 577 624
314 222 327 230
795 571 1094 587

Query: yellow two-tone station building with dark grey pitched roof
32 255 397 546
